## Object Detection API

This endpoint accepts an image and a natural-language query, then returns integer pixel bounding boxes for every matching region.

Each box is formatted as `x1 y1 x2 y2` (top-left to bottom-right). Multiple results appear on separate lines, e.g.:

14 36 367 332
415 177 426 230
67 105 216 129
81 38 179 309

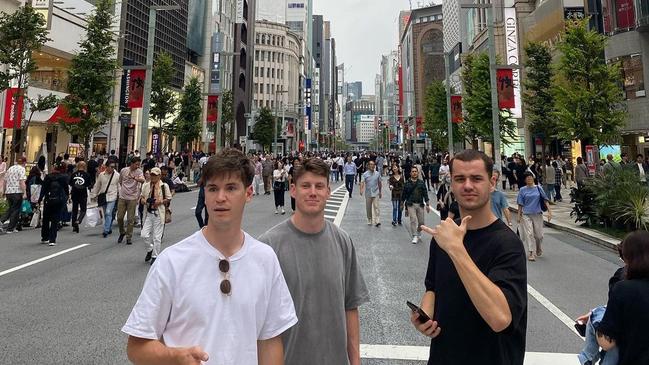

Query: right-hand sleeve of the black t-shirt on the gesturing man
487 234 527 323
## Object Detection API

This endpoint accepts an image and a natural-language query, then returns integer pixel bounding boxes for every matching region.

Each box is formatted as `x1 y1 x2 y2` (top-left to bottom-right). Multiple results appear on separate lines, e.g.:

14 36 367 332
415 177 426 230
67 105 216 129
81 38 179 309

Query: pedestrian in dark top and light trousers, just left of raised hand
402 166 430 244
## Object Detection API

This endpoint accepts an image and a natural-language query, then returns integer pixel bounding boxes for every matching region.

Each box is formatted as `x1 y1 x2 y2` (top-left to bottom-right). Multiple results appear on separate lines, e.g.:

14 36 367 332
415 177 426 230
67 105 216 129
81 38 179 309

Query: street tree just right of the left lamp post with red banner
150 52 178 150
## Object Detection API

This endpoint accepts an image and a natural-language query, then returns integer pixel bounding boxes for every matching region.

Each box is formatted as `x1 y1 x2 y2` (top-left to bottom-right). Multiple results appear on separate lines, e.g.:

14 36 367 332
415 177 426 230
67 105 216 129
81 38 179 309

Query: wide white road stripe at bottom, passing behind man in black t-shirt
361 344 579 365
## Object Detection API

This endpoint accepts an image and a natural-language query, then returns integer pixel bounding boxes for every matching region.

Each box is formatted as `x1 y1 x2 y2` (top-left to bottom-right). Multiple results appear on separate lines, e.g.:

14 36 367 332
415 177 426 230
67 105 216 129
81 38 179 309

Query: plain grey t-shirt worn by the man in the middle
259 219 369 365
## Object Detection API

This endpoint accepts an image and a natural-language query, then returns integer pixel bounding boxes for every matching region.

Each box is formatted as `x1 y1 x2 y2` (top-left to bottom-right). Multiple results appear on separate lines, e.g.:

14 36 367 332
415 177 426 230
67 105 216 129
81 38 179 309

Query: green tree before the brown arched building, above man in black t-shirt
424 81 463 151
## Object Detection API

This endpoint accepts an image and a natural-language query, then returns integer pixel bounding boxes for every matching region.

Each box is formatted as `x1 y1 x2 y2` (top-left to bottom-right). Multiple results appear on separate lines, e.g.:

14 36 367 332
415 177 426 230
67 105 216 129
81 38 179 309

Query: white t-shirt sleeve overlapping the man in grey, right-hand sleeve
258 253 297 340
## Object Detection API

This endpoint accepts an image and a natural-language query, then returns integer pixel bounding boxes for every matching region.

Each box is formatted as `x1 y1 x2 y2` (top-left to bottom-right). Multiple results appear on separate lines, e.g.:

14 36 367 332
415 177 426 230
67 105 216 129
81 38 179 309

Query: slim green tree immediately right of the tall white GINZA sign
523 42 558 155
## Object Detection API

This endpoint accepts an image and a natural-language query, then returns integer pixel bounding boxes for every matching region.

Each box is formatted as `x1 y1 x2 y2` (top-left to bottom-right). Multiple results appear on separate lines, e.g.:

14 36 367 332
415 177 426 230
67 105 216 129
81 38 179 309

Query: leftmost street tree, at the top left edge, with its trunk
0 4 50 163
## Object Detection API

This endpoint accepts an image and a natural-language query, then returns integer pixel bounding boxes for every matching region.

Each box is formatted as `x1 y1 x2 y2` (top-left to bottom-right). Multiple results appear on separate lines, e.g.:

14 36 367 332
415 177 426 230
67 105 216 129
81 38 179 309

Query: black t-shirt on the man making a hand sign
425 219 527 365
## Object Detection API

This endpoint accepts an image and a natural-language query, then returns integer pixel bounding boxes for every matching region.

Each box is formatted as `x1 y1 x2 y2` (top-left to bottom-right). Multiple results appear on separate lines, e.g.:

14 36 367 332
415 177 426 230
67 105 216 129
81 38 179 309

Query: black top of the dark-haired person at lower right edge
597 279 649 365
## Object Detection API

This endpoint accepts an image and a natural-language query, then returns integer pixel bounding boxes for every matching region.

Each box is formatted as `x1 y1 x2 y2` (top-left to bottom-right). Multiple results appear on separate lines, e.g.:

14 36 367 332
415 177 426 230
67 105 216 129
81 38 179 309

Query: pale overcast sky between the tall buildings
313 0 416 95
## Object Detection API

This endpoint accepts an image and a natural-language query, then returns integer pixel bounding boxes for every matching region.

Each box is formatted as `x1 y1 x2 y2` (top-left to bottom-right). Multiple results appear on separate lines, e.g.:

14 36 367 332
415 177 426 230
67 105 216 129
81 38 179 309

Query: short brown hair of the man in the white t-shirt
201 148 255 188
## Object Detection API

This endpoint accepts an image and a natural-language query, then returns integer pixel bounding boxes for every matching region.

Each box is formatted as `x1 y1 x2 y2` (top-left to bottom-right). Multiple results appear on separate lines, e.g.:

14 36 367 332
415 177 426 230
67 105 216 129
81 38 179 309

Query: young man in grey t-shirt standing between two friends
259 158 369 365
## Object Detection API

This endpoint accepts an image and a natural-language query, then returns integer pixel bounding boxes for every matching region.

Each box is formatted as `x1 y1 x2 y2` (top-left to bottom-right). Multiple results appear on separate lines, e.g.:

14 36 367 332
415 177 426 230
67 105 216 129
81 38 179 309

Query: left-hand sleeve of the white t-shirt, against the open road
122 256 172 340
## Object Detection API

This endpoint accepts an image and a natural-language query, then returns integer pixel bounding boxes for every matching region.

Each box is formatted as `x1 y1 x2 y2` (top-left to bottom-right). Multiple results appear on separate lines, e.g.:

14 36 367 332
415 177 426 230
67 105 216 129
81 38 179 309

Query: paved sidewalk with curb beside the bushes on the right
505 189 620 252
